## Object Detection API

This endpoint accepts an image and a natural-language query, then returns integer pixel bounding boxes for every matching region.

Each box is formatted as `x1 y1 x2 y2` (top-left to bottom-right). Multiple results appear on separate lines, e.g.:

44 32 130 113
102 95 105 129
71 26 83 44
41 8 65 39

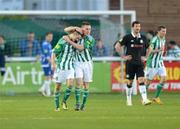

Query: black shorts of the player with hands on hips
126 61 144 80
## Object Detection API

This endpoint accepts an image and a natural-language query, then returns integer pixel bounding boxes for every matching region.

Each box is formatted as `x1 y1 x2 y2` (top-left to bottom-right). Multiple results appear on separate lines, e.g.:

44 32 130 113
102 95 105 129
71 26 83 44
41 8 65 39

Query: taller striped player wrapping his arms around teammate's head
65 22 95 111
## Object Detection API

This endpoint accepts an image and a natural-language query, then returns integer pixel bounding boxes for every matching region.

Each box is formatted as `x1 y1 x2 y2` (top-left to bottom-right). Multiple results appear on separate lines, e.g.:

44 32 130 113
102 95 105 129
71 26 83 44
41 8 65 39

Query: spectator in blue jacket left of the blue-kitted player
20 32 41 57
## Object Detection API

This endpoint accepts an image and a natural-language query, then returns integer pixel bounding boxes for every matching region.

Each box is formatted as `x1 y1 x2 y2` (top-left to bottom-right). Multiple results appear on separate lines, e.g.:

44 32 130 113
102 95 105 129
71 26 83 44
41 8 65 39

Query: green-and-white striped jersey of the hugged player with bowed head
52 38 75 70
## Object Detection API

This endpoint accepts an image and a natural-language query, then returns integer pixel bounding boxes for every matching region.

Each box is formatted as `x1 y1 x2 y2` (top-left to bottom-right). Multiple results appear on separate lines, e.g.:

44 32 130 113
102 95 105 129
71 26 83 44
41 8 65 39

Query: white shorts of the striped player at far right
145 67 166 80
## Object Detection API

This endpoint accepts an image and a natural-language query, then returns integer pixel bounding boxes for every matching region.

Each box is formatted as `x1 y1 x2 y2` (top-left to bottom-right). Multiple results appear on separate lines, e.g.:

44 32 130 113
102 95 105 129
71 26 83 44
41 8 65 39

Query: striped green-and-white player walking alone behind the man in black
146 26 166 104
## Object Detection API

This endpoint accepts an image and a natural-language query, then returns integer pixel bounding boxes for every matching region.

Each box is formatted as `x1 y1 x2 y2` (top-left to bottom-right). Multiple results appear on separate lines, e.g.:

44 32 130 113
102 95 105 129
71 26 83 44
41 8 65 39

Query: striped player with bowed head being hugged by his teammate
52 30 82 111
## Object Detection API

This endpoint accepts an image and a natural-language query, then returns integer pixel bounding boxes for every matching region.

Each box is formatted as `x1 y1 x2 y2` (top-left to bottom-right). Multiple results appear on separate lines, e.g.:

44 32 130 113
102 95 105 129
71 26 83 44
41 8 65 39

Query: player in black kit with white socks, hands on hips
115 21 151 106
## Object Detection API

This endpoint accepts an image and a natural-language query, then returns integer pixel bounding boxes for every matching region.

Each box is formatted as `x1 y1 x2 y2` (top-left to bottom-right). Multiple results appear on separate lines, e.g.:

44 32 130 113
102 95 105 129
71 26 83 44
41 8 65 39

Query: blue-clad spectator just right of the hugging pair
93 39 108 57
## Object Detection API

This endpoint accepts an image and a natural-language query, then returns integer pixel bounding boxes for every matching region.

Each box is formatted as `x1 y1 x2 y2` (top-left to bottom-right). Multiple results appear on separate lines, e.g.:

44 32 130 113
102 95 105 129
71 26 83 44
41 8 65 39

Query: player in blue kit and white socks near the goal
39 32 53 96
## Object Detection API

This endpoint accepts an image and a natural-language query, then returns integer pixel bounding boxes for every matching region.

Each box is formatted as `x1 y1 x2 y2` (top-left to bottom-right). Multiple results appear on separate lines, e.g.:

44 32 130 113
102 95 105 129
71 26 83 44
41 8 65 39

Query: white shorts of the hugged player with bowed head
53 69 74 83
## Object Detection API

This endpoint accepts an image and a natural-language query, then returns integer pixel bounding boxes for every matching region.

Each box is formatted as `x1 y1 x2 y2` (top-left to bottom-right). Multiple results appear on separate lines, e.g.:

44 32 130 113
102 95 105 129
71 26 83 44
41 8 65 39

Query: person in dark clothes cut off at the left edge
0 35 6 76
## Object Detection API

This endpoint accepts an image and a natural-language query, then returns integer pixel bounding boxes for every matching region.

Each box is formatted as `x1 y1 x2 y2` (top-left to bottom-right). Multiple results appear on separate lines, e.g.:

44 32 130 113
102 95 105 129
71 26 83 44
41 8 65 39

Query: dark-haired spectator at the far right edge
167 40 180 57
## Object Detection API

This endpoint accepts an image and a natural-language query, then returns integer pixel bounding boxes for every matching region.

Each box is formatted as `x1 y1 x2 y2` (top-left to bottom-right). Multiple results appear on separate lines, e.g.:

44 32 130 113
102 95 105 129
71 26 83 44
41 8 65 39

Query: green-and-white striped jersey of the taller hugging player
75 35 96 62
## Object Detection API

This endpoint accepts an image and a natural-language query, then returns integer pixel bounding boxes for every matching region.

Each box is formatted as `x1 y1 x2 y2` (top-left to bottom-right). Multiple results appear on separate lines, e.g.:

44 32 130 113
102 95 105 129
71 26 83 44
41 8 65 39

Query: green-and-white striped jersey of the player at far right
146 36 166 68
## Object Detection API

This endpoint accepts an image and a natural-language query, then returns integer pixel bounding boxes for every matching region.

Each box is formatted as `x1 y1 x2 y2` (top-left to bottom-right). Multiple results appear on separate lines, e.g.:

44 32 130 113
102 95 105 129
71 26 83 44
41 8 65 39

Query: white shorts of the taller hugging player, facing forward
74 61 93 82
